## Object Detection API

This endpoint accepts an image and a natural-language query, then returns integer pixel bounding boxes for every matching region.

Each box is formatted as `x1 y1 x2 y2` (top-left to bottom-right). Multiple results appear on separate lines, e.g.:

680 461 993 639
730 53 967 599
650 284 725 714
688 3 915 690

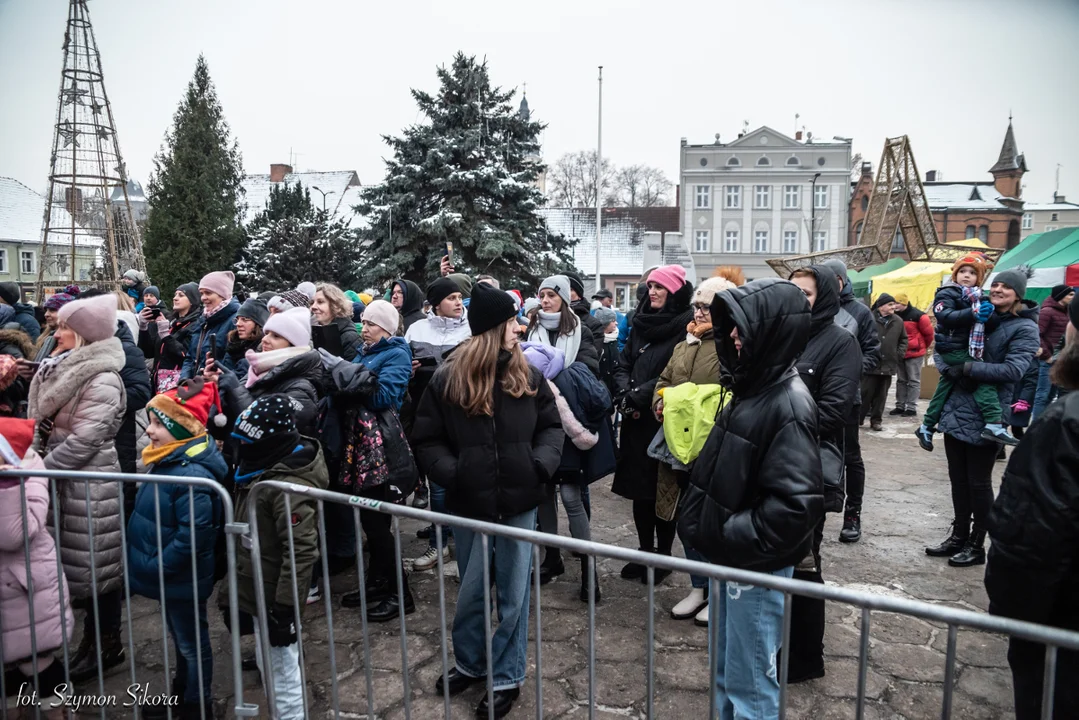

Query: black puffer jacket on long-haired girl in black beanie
411 352 565 521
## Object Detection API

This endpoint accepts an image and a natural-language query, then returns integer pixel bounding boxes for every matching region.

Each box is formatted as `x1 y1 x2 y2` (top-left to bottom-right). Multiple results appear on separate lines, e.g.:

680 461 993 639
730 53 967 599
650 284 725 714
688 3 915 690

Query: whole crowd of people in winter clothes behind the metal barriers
0 253 1079 718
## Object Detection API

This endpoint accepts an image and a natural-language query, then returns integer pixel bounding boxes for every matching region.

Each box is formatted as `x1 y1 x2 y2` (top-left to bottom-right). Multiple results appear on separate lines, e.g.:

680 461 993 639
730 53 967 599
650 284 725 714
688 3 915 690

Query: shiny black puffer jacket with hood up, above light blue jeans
679 280 824 572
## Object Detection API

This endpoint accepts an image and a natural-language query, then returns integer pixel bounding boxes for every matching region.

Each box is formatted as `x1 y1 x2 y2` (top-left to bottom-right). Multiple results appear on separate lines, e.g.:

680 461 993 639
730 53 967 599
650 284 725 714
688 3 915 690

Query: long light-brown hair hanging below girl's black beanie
443 323 536 416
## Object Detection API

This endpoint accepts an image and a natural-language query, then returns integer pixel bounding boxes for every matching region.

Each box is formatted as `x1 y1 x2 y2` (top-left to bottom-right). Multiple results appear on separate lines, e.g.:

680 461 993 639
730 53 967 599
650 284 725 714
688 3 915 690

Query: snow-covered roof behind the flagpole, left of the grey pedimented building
540 207 679 275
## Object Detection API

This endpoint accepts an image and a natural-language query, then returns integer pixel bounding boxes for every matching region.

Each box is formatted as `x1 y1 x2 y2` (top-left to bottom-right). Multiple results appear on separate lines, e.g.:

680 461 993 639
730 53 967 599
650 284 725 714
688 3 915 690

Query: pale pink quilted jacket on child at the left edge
0 450 74 663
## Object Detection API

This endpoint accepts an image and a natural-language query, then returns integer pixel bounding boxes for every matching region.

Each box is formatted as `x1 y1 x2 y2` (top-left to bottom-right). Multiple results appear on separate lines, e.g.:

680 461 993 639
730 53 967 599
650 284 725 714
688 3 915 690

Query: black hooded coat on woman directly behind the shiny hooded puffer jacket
795 266 862 450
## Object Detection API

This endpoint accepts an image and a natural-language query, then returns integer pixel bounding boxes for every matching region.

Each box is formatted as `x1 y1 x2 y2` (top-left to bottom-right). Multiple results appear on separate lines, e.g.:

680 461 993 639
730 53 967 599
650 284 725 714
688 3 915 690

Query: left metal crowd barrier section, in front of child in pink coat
0 468 258 720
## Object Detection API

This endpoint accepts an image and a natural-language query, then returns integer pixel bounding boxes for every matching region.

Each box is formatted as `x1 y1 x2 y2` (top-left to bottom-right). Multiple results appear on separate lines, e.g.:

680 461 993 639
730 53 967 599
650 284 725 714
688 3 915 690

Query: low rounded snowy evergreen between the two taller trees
236 182 361 290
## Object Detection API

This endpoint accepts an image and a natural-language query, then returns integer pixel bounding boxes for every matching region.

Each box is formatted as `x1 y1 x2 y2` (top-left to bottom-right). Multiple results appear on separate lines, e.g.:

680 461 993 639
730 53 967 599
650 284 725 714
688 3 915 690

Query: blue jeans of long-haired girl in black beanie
453 509 536 691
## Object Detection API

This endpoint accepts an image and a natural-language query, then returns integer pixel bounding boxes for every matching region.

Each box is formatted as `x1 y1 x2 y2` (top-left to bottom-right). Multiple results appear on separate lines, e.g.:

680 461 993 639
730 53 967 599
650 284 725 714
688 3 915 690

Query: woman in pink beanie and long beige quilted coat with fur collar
29 294 126 682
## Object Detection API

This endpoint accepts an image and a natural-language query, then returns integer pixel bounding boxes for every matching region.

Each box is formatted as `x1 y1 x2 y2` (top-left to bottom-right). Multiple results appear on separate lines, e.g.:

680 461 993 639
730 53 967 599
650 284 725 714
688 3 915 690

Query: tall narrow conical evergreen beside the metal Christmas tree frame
142 55 244 297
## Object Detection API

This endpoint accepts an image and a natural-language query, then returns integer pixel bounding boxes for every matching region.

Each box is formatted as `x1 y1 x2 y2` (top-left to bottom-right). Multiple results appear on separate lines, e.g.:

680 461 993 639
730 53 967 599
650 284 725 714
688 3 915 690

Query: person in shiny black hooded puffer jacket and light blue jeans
681 275 824 718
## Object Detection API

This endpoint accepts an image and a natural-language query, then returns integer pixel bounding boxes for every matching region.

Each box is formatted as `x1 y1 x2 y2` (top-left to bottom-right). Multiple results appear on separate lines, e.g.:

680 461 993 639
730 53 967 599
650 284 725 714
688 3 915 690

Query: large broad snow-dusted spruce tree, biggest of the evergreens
356 53 573 289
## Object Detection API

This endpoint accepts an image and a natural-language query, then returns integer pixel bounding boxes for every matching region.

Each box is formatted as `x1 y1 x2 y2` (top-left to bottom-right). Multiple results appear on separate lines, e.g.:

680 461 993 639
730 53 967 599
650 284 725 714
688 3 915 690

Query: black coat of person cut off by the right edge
985 393 1079 630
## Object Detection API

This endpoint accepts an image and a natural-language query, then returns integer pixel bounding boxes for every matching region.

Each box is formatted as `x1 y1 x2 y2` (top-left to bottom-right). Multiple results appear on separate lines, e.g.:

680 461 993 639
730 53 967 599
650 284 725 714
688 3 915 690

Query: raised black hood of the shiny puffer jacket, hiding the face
711 280 812 397
